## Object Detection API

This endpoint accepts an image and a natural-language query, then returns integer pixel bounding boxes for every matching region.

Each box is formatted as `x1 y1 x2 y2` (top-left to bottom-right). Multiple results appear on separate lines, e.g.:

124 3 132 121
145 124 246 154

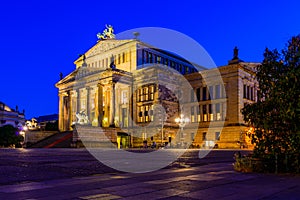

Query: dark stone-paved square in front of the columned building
0 149 300 200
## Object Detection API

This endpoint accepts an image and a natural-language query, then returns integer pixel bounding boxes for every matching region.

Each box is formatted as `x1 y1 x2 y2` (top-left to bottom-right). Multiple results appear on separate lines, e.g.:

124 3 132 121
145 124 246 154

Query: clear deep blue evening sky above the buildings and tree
0 0 300 118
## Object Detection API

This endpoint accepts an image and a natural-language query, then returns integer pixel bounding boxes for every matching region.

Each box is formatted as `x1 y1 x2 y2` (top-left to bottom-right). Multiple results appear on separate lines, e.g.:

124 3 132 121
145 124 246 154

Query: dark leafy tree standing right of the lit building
242 35 300 170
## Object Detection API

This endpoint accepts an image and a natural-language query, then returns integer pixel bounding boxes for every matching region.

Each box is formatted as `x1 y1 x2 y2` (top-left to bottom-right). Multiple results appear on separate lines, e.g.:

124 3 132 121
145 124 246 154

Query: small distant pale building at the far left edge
0 102 25 128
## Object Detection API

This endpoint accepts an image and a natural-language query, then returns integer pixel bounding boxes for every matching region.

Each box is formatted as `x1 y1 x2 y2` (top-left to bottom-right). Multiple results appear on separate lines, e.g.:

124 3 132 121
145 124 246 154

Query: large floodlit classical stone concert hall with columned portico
56 28 259 148
